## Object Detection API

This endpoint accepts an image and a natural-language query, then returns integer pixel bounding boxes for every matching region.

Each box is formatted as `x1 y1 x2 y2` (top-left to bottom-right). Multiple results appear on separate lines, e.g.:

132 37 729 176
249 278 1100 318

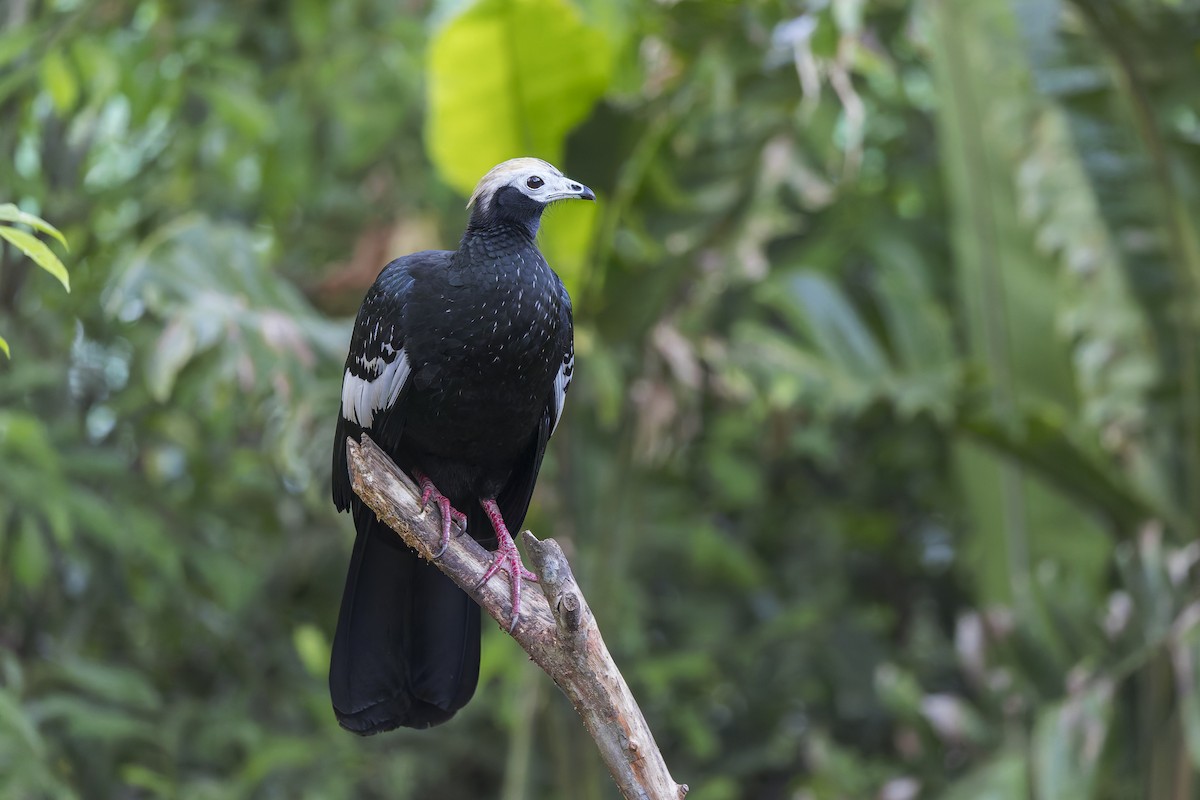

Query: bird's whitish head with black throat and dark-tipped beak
467 158 596 236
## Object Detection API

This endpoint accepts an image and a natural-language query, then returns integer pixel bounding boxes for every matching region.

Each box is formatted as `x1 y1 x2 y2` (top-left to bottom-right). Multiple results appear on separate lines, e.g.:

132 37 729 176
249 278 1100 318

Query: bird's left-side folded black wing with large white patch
332 251 451 511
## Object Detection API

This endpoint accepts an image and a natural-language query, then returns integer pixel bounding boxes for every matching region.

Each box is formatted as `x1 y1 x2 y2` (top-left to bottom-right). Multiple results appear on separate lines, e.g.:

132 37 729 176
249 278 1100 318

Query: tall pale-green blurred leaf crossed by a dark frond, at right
923 0 1106 602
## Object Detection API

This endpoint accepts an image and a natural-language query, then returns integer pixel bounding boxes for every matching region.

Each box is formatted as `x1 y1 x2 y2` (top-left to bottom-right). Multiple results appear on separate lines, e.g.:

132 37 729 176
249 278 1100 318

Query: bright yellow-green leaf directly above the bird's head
425 0 613 194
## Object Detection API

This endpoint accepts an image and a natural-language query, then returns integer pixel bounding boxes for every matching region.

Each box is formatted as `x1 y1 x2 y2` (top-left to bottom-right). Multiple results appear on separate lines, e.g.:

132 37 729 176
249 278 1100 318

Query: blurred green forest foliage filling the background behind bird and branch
0 0 1200 800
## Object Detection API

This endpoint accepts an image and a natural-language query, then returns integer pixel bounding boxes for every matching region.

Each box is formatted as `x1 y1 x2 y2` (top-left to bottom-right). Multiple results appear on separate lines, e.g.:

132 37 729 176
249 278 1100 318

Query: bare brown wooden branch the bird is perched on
346 435 688 800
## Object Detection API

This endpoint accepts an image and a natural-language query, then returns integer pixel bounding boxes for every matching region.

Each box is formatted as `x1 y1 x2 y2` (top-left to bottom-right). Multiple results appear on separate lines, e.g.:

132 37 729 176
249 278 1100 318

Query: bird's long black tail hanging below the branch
329 499 480 735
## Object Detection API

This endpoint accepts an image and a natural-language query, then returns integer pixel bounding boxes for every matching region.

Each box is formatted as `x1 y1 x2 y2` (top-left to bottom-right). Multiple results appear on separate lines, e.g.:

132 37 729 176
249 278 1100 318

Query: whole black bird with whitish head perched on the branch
329 157 595 735
